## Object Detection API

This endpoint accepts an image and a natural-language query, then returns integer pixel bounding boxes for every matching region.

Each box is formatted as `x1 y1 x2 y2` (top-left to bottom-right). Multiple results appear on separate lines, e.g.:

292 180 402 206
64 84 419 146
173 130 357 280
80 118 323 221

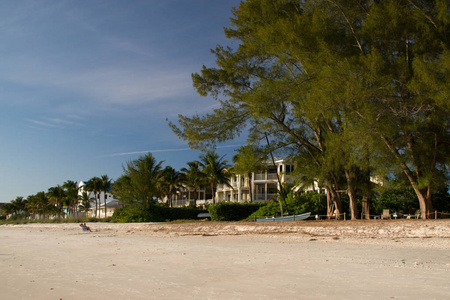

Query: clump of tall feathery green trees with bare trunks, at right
170 0 450 218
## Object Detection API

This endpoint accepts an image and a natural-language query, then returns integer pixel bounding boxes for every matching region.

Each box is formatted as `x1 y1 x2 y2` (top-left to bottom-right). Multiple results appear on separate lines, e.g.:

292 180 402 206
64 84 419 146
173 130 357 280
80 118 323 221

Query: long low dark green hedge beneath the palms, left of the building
112 204 206 223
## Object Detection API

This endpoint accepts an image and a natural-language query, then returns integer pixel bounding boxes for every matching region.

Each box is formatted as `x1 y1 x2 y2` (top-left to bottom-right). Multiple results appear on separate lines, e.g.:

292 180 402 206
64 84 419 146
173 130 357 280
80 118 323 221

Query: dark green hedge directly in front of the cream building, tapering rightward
208 202 266 221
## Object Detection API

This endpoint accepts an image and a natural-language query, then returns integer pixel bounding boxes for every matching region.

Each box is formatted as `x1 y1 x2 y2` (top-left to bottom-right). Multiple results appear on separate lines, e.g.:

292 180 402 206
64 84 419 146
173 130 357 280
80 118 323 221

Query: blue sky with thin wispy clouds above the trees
0 0 245 202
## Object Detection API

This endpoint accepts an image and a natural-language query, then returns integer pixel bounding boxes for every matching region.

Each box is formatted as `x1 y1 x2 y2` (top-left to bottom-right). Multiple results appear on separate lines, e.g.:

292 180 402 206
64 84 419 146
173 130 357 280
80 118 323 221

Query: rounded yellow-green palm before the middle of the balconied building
232 145 266 202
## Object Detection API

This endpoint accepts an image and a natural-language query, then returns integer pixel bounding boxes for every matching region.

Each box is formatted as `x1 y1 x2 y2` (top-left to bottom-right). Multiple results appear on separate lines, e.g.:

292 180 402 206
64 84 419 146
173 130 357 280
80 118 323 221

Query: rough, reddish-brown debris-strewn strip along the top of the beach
0 219 450 242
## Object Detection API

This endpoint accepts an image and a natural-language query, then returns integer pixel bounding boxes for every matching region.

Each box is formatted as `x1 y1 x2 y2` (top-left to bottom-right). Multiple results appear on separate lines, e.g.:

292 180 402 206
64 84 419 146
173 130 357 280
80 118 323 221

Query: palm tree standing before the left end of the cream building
200 151 230 204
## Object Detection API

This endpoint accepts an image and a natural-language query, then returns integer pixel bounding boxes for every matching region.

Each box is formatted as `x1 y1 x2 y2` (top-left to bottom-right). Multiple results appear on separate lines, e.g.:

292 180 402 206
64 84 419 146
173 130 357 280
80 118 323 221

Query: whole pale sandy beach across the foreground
0 220 450 300
